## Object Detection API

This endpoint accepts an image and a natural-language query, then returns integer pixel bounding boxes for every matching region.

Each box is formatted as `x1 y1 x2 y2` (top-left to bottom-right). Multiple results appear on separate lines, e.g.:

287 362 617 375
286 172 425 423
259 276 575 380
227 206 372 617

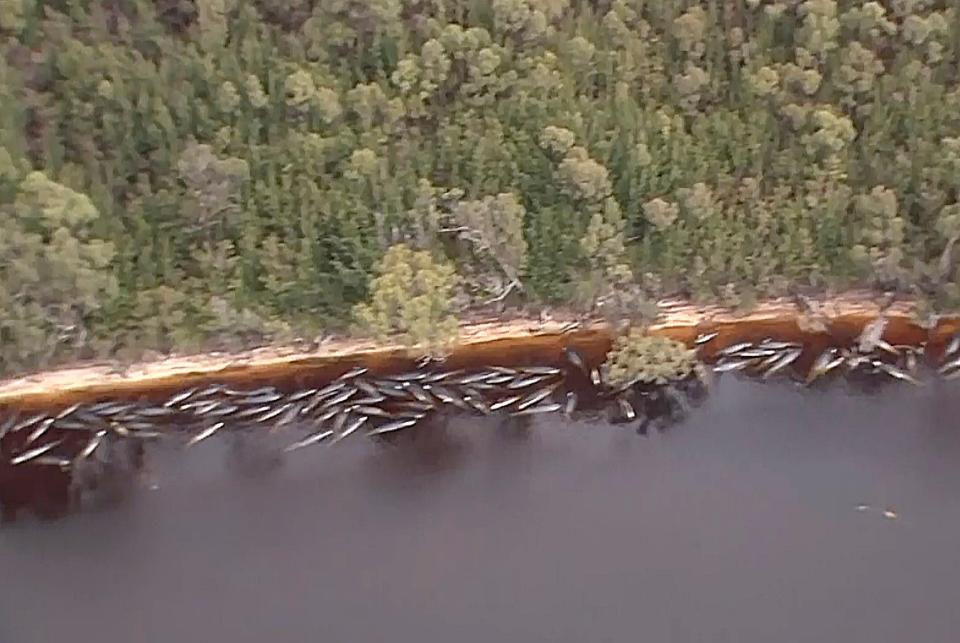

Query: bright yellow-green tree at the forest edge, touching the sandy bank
355 244 458 353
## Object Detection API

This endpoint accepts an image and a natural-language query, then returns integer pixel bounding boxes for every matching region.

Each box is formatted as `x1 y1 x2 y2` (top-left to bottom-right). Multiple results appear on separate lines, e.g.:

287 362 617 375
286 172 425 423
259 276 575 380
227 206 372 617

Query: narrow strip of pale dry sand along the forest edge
0 293 944 404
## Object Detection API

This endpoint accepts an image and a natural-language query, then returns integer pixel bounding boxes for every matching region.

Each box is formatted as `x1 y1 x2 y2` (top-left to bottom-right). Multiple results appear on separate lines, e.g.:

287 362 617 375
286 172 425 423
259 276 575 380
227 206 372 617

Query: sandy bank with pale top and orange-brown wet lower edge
0 292 948 408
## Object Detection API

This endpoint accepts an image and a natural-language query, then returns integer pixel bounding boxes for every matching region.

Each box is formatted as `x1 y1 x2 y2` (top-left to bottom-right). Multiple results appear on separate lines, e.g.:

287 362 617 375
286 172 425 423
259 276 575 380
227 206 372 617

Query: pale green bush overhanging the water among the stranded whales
603 327 696 387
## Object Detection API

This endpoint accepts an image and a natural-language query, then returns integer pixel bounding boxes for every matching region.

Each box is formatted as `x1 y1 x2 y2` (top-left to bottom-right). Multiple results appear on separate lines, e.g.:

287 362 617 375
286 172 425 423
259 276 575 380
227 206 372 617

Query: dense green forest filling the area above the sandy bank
0 0 960 374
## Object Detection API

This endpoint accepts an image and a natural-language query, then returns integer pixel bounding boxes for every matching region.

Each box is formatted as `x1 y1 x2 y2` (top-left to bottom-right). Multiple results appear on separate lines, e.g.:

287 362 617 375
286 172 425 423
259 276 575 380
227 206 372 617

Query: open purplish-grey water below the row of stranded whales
0 377 960 643
